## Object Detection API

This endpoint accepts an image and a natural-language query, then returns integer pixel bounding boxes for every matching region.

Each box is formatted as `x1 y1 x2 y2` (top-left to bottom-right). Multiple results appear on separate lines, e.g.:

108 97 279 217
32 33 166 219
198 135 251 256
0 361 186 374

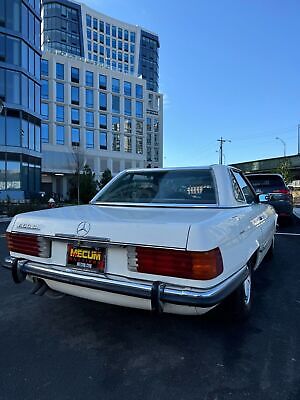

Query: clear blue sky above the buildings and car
84 0 300 166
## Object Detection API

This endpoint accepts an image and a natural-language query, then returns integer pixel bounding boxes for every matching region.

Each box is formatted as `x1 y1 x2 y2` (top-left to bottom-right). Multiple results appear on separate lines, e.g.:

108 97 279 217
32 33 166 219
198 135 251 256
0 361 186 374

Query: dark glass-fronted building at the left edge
0 0 41 200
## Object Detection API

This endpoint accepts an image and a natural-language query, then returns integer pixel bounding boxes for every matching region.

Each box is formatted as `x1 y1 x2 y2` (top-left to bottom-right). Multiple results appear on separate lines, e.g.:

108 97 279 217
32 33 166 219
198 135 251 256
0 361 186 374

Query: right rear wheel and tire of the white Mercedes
224 267 253 321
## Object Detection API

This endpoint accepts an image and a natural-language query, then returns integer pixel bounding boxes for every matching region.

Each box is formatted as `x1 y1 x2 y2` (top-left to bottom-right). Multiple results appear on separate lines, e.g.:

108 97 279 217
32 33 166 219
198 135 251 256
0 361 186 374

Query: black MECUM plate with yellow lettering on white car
67 244 106 272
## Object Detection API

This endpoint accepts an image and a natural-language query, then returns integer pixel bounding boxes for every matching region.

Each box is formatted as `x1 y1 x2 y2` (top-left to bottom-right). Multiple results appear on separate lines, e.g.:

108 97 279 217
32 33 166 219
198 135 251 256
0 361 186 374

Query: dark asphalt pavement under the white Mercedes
0 218 300 400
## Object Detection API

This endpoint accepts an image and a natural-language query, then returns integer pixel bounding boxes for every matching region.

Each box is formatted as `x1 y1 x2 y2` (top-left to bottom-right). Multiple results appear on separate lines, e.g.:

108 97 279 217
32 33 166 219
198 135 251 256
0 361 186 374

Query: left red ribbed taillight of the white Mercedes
6 232 50 258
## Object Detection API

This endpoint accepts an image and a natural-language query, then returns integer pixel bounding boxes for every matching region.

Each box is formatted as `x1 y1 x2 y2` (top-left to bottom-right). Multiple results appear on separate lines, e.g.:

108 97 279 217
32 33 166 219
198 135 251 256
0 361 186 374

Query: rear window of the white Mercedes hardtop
95 169 216 204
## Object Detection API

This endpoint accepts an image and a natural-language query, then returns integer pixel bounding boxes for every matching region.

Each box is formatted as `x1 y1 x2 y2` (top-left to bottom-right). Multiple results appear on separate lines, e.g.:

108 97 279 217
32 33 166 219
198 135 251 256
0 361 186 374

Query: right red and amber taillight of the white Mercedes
136 247 223 280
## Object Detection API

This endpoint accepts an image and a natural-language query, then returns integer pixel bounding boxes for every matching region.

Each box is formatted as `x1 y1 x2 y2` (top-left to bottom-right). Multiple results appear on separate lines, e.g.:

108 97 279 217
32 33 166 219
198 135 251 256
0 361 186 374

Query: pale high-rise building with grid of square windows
41 0 163 198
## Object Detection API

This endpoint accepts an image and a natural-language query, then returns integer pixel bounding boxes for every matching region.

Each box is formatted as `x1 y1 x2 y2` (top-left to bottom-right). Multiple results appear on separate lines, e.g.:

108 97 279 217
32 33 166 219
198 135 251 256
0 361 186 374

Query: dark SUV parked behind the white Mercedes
246 174 293 218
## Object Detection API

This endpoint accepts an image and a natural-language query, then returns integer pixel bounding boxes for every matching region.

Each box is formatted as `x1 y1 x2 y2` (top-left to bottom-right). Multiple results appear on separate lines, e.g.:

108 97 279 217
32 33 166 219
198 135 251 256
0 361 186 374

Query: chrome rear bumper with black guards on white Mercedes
3 257 249 311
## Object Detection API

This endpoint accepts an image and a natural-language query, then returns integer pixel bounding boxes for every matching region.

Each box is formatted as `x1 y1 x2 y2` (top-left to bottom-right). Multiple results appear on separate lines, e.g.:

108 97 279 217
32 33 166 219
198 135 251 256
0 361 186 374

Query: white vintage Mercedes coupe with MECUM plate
4 165 277 318
